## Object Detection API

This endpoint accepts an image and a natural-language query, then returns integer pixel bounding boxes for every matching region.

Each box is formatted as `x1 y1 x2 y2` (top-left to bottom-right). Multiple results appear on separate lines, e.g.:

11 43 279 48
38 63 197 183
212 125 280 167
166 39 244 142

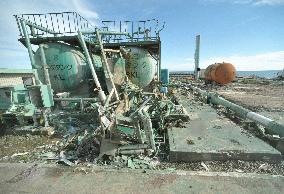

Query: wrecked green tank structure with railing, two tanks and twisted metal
2 12 191 164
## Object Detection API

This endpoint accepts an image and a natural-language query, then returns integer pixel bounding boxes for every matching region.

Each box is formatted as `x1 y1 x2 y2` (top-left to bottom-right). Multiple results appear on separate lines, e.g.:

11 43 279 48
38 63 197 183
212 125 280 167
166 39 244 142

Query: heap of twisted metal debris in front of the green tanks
1 80 189 169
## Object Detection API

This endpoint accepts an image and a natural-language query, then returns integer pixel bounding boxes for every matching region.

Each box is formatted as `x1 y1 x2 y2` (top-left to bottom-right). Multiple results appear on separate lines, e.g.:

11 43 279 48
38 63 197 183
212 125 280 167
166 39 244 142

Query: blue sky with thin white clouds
0 0 284 70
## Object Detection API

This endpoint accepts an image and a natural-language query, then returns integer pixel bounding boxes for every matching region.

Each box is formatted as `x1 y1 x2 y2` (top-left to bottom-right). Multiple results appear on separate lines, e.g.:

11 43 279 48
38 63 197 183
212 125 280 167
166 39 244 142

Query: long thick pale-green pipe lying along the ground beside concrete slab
190 85 284 138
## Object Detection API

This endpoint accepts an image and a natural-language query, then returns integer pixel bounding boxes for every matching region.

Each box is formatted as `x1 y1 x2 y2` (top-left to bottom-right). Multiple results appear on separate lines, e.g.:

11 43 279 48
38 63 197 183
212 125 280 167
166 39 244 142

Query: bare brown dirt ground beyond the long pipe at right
201 79 284 124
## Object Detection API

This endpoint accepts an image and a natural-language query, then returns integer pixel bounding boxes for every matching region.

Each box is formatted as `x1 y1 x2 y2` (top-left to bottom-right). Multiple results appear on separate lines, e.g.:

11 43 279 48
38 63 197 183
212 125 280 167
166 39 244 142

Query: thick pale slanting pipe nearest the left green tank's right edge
78 31 106 103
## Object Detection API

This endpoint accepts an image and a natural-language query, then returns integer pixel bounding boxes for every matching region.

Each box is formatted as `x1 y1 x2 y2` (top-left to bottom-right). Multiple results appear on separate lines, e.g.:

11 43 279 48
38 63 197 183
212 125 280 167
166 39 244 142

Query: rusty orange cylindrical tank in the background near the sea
204 63 236 85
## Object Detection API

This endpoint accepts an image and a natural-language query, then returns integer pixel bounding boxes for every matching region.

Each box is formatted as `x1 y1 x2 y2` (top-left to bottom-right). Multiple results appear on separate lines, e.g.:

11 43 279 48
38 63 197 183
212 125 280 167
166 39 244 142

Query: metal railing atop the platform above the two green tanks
14 12 164 43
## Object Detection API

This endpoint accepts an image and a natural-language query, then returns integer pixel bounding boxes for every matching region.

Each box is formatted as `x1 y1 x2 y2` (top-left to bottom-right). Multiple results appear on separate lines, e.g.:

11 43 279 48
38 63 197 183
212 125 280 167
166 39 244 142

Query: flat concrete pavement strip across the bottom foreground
0 163 284 194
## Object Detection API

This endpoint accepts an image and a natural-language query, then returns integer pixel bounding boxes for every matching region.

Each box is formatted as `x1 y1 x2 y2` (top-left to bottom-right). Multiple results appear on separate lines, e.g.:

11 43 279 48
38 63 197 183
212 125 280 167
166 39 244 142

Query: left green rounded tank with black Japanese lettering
34 43 91 93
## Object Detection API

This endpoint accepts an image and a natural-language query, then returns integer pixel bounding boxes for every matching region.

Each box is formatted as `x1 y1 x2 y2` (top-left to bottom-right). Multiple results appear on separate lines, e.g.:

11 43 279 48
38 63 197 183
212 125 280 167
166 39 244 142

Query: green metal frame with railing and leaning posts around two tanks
14 12 164 93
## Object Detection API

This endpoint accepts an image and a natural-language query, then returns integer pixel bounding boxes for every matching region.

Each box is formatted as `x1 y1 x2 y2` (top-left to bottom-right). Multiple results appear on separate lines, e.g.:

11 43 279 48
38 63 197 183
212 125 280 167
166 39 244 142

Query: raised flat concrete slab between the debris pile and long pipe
168 95 281 162
